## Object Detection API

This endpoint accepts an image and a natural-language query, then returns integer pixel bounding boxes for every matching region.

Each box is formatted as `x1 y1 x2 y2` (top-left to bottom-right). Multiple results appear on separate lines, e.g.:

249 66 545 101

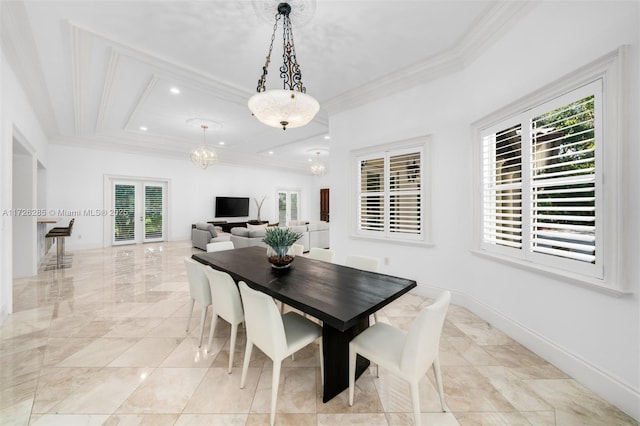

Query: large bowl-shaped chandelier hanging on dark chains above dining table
248 3 320 130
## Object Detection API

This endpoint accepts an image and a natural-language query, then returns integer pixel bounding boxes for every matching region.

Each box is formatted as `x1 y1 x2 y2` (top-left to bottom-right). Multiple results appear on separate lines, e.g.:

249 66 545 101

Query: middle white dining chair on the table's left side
202 265 244 374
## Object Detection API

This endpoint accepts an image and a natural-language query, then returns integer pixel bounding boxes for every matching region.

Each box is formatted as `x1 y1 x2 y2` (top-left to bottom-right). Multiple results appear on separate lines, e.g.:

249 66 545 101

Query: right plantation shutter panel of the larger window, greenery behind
531 96 596 263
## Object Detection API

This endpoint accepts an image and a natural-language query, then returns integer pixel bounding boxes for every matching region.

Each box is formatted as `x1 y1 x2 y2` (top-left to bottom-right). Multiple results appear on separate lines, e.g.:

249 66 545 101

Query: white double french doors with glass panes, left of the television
111 180 167 245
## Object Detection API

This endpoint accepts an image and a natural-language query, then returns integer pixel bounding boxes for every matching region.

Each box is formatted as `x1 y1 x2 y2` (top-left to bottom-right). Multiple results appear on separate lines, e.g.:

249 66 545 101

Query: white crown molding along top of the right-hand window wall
323 0 535 114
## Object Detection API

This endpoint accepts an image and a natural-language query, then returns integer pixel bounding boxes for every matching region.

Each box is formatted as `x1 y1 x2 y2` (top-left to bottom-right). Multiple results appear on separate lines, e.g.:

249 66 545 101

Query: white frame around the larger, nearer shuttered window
472 46 627 292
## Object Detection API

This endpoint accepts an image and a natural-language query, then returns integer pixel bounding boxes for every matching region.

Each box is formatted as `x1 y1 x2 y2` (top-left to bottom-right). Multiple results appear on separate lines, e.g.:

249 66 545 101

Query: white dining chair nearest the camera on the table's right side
349 291 451 425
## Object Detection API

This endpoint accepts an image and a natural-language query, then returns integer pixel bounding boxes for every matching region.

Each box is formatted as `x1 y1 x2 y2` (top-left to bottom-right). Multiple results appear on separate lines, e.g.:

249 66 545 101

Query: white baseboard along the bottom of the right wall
414 286 640 421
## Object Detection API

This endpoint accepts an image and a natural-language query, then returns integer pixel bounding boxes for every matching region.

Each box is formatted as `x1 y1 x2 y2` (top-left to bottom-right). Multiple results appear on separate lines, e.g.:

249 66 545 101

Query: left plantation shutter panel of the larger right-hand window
482 125 522 249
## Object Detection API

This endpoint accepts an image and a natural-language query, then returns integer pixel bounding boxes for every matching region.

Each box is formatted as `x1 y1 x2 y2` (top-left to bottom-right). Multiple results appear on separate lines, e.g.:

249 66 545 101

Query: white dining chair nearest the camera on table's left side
239 281 324 426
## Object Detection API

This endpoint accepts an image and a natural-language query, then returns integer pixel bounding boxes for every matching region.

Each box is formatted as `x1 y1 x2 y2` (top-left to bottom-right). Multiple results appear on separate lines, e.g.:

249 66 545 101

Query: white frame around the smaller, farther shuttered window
349 136 431 245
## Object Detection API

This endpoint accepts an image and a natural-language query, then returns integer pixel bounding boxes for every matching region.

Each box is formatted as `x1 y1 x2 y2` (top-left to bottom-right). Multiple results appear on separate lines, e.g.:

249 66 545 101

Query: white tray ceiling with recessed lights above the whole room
2 0 525 171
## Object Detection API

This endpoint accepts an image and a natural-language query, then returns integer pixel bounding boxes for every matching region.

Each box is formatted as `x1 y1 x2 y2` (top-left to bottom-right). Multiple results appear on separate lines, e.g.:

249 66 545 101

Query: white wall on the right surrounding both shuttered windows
330 2 640 419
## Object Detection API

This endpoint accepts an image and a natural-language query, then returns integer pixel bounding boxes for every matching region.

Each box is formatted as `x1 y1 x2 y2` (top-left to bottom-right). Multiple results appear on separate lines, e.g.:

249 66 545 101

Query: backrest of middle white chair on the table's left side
204 267 244 324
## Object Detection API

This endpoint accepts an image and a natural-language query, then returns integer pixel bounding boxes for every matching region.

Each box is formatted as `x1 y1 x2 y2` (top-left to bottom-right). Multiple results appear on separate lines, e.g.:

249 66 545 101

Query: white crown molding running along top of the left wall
0 1 60 138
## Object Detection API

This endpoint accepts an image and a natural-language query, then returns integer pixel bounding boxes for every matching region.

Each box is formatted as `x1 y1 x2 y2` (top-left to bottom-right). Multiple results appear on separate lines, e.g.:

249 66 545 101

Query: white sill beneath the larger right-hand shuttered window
470 249 632 297
